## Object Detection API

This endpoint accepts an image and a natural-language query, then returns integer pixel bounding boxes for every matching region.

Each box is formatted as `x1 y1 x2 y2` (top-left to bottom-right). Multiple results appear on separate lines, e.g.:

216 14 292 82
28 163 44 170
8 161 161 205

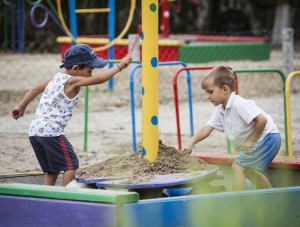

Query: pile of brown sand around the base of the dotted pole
76 141 216 184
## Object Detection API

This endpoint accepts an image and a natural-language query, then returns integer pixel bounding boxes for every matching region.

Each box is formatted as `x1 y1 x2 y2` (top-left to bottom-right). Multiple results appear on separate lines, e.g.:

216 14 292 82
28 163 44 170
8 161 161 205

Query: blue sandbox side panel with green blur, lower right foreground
123 187 300 227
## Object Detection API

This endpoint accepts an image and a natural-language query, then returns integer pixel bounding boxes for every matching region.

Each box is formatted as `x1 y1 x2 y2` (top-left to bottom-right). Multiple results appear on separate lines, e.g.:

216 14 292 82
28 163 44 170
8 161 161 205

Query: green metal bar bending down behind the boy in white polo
232 68 289 154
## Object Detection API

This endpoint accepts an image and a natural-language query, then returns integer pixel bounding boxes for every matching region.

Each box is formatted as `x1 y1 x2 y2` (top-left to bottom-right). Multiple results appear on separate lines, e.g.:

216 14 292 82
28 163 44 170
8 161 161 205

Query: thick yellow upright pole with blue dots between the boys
141 0 158 162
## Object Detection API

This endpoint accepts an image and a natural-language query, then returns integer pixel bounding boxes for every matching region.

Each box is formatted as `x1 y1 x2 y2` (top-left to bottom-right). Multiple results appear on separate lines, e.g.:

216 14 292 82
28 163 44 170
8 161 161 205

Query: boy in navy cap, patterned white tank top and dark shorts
11 44 132 186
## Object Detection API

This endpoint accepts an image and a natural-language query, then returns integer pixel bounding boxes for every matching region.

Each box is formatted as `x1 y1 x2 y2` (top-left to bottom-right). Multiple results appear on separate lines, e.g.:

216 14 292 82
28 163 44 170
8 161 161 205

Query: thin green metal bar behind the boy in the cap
83 60 141 151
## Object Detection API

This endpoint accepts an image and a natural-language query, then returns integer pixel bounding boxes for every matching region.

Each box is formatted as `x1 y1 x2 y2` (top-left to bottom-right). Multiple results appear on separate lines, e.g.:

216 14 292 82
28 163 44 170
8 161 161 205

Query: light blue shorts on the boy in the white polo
234 133 281 172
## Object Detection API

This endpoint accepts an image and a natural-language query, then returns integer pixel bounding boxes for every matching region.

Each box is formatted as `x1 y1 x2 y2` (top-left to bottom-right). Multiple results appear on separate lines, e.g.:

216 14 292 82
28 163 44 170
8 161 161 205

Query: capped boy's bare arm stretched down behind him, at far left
11 79 51 120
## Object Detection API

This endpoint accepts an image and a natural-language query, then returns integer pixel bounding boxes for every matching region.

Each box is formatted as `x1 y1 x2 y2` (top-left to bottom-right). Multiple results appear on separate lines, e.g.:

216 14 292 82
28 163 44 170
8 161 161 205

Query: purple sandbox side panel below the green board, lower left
0 195 120 227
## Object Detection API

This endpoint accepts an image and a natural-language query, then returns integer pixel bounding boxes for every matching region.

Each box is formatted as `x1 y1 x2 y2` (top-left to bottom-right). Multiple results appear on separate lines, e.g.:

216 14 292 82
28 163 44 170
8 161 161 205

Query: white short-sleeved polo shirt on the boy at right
206 92 279 151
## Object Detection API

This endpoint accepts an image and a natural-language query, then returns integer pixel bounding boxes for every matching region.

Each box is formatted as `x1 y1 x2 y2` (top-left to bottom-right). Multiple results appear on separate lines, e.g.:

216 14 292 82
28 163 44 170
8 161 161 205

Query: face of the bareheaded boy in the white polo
203 79 230 108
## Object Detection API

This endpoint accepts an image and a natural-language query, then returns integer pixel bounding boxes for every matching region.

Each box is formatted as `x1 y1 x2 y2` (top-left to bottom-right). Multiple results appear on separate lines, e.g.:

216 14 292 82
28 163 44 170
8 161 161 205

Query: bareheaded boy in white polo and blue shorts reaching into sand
184 66 281 191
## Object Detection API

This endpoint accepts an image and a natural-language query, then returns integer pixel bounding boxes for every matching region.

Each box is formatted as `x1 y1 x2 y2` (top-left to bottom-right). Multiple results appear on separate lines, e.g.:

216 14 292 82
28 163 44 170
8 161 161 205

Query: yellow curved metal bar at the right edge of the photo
285 71 300 159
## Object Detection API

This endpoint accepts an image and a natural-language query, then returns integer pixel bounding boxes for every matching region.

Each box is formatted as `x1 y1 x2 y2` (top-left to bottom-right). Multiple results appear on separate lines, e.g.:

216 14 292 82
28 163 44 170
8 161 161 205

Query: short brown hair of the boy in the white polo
201 66 235 92
